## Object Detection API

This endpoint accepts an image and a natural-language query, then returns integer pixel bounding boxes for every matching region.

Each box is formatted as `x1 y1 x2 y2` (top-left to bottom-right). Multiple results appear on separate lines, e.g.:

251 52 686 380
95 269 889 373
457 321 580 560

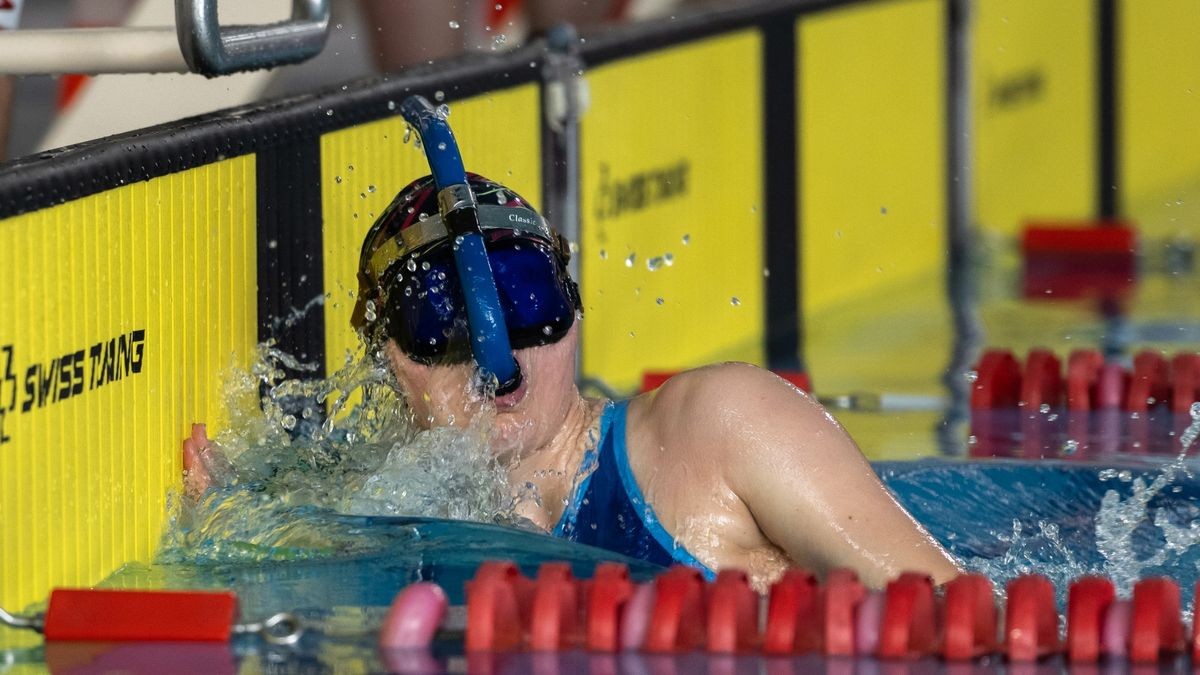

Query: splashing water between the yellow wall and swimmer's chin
158 342 536 563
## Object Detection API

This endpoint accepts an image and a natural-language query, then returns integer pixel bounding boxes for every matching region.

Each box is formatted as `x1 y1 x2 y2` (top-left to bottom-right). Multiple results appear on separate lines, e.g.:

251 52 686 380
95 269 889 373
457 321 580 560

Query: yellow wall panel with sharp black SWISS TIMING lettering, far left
0 156 257 609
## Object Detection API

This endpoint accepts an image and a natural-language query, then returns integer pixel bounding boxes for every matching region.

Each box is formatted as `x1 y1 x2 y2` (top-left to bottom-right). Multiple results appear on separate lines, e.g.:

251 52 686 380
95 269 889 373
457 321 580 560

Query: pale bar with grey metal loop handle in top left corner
0 0 330 77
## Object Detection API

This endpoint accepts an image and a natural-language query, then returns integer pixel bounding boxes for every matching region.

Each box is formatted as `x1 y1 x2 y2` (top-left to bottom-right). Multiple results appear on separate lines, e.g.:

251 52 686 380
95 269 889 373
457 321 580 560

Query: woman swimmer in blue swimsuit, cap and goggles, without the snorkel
353 175 959 587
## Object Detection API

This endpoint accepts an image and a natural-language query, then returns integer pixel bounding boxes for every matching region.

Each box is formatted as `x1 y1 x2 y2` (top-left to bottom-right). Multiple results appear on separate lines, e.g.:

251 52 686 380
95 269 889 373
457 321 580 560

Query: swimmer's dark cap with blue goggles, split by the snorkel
350 174 581 363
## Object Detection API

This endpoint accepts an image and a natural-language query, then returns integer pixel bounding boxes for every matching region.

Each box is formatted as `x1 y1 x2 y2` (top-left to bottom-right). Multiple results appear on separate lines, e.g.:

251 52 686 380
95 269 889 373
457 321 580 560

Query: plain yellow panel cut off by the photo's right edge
1117 0 1200 239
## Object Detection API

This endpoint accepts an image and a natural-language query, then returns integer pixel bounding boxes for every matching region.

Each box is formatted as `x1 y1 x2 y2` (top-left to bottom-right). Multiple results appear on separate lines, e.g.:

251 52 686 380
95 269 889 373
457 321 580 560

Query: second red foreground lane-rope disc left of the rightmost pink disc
1004 574 1058 662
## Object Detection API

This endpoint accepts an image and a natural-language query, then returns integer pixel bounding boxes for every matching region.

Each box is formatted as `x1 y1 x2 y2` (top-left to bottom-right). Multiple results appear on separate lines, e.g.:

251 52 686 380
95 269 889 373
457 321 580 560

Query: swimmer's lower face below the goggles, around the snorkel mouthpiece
385 321 580 460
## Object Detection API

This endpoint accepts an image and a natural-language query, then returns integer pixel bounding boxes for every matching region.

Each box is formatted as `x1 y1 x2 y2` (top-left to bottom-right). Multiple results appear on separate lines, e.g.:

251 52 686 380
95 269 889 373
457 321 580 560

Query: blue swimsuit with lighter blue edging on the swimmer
553 401 714 579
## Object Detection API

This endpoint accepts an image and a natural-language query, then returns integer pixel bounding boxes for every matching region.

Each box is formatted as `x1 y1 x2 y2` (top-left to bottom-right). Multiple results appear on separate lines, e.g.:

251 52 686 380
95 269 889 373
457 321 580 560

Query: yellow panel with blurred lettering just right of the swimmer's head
581 30 768 390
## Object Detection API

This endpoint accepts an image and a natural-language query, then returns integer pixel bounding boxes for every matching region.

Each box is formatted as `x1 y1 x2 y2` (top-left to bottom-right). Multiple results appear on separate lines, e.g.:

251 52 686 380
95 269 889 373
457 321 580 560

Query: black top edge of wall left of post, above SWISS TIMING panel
0 50 541 219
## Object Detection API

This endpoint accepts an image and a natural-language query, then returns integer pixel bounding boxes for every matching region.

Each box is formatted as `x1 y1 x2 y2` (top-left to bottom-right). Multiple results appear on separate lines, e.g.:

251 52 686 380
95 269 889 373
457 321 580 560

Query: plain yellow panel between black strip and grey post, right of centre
797 0 946 393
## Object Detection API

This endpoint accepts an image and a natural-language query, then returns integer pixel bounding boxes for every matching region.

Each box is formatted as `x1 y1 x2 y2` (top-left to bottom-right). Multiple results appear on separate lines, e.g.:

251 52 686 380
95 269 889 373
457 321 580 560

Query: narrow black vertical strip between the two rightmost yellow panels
1096 0 1121 219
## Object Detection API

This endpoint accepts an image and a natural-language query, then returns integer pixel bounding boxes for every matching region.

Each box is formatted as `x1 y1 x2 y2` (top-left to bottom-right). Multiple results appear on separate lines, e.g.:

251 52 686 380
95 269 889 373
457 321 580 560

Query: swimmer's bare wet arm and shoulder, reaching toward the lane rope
681 364 960 587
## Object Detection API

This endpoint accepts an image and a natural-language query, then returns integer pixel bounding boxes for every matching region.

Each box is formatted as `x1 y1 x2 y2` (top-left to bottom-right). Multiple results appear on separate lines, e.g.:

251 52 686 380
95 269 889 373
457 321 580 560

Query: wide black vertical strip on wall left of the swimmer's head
256 136 325 377
